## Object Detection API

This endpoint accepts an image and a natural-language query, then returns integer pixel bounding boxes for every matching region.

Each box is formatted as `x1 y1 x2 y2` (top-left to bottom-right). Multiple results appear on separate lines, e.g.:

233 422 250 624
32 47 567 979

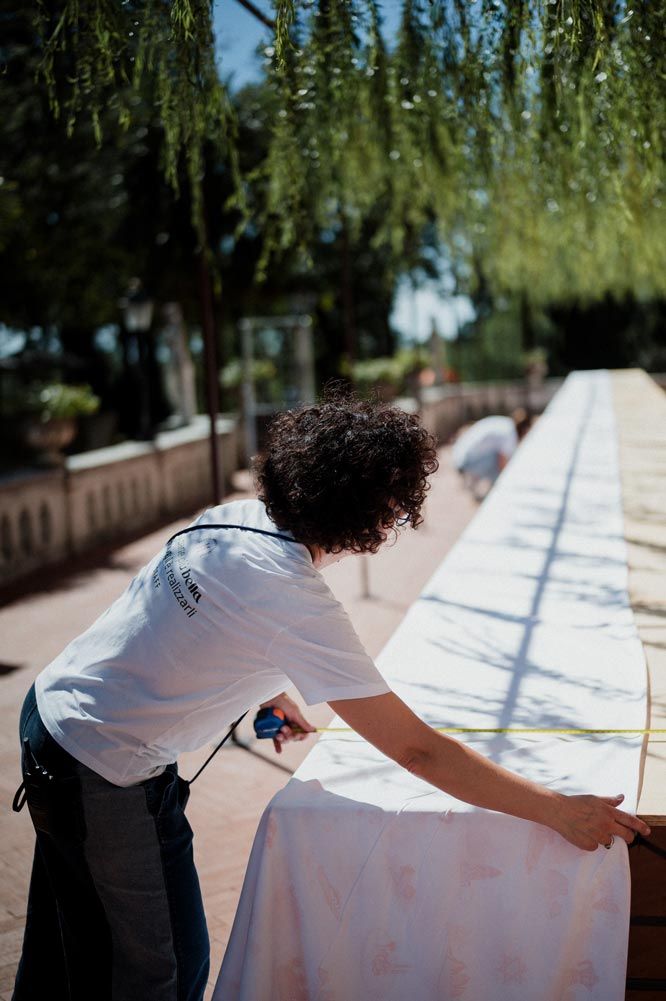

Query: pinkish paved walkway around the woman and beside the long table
0 448 477 1001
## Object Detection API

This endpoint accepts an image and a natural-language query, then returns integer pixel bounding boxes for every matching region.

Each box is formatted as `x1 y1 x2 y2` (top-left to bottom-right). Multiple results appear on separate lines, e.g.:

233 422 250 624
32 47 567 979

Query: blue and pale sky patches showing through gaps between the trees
213 0 474 341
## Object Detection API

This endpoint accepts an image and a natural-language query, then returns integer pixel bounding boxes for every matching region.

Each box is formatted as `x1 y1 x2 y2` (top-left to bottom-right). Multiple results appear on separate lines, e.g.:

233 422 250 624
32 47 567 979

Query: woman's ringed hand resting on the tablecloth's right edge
551 795 650 852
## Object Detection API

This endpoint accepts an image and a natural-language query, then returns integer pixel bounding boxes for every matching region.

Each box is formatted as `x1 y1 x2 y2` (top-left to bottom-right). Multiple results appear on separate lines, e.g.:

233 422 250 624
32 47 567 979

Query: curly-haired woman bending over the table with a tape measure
14 395 646 1001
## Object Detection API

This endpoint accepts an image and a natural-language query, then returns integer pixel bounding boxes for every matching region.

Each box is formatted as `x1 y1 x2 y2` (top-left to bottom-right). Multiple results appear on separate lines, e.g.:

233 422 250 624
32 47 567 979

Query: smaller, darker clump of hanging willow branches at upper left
36 0 241 230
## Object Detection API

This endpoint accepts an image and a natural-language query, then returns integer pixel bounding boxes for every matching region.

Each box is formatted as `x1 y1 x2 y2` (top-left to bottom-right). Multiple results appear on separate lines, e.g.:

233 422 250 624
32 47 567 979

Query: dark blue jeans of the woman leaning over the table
13 689 209 1001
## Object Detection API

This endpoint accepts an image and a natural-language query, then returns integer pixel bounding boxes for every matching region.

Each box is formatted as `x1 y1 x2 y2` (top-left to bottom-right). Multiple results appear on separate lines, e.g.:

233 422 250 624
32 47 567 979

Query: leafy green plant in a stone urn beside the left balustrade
23 382 99 465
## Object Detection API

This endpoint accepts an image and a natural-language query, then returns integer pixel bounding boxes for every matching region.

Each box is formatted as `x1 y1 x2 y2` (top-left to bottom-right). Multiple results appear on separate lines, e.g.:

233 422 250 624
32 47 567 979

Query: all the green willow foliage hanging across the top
29 0 666 301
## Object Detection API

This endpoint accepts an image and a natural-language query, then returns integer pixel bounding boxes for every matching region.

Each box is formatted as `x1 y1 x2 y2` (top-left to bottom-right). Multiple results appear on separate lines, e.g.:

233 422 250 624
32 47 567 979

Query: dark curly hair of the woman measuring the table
253 390 439 553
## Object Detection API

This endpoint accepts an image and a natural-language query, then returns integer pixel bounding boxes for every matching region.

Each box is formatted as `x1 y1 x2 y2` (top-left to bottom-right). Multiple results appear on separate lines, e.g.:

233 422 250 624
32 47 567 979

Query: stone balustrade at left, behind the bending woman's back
0 416 238 586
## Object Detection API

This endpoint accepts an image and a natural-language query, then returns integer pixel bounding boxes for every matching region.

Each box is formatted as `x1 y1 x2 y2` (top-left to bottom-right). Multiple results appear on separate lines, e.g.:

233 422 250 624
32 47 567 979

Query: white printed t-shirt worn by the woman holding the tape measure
35 501 390 786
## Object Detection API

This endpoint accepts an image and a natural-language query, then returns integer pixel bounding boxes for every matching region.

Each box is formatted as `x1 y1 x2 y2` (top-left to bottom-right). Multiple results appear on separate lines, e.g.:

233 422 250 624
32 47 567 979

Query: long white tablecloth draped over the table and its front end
214 372 647 1001
